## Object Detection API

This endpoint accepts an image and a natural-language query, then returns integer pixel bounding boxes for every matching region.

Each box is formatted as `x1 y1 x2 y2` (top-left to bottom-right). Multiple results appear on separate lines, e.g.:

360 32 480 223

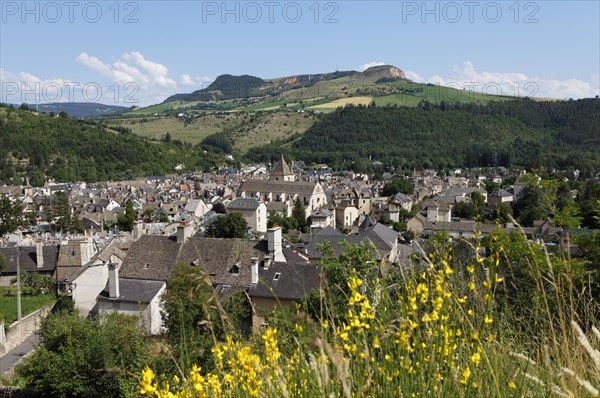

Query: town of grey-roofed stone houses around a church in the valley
0 155 593 336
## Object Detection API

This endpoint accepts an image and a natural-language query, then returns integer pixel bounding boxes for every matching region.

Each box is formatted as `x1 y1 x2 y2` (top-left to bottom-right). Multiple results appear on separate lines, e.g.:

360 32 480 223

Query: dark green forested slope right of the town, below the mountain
248 98 600 173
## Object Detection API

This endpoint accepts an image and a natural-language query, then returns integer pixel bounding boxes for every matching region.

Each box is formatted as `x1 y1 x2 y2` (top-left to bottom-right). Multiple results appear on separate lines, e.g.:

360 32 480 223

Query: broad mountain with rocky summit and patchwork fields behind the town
104 65 568 159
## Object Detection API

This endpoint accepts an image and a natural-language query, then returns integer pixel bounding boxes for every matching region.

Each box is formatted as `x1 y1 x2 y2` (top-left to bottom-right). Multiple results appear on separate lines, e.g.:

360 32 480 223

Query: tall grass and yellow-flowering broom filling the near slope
139 238 600 397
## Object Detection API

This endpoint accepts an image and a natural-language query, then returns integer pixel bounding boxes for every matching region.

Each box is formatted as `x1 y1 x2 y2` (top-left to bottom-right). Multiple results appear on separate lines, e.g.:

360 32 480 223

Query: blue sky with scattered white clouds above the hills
0 0 600 106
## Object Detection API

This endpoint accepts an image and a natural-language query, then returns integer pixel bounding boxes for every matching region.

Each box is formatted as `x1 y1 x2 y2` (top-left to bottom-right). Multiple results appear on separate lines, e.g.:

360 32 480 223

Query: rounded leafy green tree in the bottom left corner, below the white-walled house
15 312 148 397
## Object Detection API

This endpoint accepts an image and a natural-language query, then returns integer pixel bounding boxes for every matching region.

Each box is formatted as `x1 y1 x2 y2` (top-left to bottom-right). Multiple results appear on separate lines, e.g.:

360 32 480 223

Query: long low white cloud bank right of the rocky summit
406 61 600 99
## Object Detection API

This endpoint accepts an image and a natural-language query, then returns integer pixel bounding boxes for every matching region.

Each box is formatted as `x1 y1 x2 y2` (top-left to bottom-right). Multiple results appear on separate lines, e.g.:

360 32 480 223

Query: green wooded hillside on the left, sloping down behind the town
0 105 221 186
